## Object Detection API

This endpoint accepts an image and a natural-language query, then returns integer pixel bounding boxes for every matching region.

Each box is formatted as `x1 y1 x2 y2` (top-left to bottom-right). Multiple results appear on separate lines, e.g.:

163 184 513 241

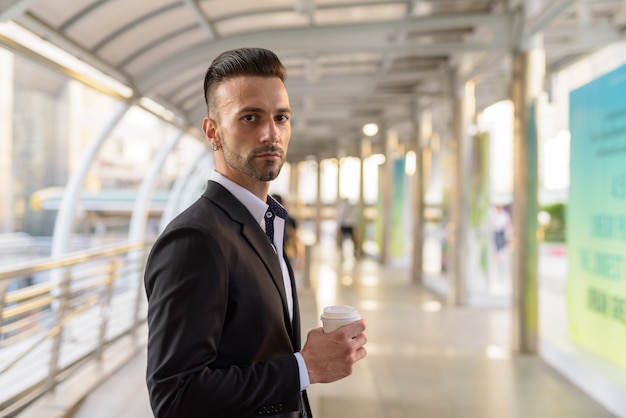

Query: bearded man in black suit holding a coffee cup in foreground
145 48 366 418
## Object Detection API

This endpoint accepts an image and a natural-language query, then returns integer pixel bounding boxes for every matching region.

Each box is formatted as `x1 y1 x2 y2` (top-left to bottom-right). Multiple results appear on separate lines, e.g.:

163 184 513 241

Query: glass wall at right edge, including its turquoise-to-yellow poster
538 42 626 416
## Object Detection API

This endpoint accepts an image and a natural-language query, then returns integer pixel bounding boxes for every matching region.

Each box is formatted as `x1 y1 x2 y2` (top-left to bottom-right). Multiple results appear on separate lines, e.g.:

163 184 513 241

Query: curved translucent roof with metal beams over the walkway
0 0 626 158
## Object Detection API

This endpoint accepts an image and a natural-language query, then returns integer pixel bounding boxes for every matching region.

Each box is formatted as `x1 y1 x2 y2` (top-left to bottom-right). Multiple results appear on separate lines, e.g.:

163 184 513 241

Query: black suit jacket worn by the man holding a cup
145 181 311 418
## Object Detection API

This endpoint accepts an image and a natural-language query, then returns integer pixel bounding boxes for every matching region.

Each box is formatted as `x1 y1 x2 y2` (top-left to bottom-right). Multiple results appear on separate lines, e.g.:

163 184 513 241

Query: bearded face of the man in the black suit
203 76 291 187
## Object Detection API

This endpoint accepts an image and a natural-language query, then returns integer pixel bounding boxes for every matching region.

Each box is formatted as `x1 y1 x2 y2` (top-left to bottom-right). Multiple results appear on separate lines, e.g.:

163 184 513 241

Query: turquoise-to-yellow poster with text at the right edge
566 62 626 368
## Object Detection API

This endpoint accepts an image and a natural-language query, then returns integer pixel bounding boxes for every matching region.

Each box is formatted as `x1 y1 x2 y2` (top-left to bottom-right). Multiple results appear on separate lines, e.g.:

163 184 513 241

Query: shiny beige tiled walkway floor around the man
70 242 613 418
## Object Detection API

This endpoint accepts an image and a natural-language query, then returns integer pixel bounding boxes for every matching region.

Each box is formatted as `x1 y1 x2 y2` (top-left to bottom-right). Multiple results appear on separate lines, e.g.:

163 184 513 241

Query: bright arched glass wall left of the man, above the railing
0 45 200 258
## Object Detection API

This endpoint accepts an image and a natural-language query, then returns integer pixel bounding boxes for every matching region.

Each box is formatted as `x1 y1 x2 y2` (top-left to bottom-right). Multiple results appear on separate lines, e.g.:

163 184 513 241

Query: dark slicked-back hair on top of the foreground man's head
204 48 287 111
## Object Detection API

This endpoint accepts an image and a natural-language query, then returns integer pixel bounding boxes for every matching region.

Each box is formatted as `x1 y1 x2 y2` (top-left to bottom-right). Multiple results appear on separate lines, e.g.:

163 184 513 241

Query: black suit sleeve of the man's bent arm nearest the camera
145 229 300 418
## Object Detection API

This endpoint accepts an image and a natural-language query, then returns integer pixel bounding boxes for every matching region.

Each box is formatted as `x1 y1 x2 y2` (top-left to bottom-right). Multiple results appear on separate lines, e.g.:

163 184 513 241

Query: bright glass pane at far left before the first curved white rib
10 55 119 236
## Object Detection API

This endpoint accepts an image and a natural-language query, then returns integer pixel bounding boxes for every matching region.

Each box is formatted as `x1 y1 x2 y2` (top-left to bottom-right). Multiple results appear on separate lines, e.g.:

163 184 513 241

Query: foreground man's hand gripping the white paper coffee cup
300 319 367 383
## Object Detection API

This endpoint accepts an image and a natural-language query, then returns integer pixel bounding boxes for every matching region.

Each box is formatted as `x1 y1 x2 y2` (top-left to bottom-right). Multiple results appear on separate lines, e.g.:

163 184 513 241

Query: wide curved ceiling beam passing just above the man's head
135 14 511 91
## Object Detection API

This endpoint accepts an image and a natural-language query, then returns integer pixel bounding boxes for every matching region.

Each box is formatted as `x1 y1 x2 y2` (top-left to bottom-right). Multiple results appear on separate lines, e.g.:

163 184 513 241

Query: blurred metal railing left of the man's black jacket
0 240 153 417
